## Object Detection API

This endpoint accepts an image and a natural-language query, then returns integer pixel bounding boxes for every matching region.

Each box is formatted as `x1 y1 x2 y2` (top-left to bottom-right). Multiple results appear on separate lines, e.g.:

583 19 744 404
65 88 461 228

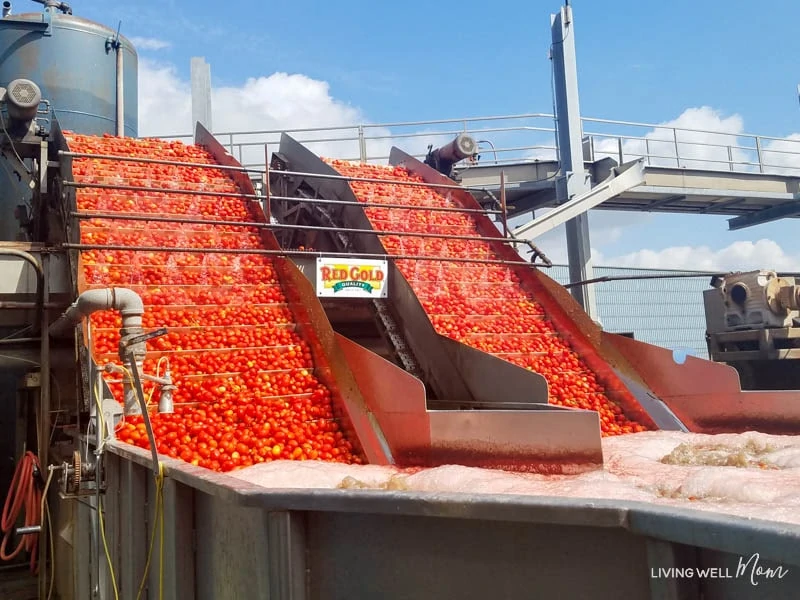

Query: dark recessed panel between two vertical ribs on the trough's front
308 513 649 600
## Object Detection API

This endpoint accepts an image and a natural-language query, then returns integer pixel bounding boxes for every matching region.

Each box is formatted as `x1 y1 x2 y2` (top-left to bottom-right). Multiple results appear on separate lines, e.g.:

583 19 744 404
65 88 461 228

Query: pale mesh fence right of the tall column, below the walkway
544 265 709 358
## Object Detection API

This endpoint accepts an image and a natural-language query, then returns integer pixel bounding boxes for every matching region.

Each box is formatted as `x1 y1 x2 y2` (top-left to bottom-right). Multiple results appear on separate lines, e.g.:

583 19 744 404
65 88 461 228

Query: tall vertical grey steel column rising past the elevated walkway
550 5 597 320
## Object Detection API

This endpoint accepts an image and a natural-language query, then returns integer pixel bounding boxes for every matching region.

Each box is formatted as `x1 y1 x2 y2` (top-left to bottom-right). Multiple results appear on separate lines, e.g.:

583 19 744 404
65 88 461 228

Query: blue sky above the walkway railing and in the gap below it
64 0 800 270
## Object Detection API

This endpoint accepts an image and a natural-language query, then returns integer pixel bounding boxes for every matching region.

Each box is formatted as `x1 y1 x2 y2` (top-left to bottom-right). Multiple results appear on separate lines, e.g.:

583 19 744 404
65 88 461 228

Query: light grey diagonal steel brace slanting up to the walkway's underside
512 160 645 241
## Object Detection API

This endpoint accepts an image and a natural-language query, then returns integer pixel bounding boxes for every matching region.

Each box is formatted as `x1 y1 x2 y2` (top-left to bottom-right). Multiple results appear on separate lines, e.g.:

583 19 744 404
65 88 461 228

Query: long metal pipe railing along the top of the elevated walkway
145 113 800 176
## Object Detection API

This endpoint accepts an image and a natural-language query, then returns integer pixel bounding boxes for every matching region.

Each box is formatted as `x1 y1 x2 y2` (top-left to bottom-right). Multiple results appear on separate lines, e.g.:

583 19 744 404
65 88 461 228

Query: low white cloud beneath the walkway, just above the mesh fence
595 239 800 271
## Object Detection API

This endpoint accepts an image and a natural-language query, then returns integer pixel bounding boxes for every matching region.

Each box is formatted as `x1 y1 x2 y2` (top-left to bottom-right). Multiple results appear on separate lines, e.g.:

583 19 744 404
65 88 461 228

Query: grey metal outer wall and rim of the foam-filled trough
97 443 800 600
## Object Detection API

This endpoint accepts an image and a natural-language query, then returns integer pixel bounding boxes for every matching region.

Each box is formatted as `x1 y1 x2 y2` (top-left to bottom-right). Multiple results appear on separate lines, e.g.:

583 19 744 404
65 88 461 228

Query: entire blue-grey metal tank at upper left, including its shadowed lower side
0 0 139 241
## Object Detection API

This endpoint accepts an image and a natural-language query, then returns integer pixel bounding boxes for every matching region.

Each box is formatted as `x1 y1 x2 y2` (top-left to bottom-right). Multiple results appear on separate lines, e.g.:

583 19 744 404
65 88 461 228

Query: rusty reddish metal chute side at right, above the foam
603 333 800 435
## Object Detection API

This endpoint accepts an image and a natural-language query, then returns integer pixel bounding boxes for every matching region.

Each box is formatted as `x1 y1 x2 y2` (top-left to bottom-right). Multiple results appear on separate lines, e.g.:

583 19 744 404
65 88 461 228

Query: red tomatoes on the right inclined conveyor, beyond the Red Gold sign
329 160 646 435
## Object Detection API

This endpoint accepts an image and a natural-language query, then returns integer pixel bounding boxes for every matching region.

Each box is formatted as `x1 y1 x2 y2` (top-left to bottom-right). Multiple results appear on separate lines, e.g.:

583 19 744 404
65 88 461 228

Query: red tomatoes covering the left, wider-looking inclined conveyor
68 134 361 471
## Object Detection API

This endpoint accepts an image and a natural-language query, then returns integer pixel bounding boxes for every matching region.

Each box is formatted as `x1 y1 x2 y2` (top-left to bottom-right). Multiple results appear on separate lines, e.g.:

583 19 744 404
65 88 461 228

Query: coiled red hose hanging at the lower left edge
0 451 42 574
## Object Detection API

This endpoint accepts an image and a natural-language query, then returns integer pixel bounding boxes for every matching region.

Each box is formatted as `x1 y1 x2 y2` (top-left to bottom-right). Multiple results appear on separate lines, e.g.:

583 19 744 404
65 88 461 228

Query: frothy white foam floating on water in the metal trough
230 431 800 524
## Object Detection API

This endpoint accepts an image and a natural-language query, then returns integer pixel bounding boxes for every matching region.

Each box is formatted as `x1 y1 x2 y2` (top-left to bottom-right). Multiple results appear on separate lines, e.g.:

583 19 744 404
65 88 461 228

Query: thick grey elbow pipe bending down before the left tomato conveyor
49 288 147 415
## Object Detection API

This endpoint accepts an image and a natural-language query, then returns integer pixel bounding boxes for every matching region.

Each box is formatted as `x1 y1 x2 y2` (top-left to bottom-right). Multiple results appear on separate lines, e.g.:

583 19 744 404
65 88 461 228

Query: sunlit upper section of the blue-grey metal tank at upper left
0 0 138 137
